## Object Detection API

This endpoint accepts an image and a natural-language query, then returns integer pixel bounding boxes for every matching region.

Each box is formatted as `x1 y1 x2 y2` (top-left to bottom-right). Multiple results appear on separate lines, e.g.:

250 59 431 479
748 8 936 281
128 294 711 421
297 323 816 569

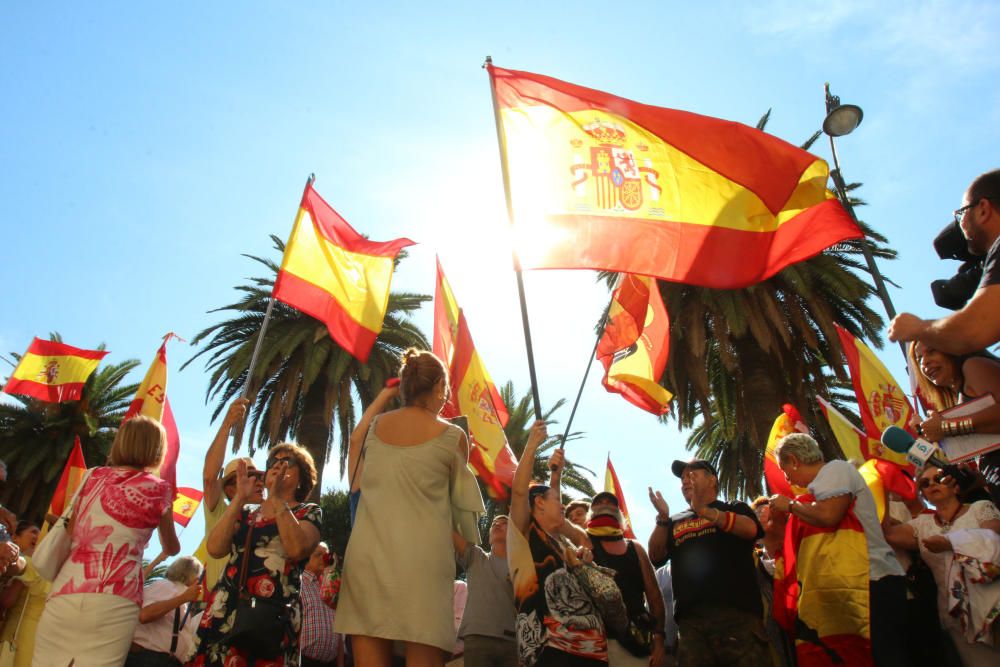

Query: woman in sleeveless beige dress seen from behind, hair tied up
334 350 483 667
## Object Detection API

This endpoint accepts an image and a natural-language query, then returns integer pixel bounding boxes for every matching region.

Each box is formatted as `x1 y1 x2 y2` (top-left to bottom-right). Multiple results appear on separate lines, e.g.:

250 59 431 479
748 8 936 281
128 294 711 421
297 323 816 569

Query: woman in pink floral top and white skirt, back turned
32 416 180 667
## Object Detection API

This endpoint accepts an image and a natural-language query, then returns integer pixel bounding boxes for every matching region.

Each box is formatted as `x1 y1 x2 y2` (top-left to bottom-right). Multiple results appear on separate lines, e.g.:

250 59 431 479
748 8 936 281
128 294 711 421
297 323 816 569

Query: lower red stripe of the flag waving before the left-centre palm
274 271 378 363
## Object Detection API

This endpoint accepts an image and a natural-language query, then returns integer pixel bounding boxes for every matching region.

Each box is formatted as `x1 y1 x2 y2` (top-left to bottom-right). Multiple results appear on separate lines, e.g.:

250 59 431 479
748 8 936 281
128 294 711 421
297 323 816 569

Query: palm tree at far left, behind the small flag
0 333 139 521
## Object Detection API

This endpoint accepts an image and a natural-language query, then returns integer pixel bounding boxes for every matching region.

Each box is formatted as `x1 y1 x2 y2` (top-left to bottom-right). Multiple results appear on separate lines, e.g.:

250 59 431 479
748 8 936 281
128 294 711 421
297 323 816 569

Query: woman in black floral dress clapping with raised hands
192 443 322 667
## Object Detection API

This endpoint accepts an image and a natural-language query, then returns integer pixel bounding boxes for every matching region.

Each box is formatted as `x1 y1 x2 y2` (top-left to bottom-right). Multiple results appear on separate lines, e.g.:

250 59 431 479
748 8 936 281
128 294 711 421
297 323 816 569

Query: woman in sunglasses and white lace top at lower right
885 466 1000 667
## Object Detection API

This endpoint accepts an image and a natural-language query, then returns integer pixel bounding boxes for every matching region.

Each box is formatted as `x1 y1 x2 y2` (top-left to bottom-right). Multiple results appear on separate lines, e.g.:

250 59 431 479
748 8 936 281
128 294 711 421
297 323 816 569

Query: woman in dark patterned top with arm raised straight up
507 420 608 667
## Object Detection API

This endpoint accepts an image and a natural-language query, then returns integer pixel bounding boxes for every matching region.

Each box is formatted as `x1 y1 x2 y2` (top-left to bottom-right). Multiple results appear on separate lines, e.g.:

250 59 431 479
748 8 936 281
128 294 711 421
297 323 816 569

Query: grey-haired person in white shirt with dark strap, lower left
125 556 203 667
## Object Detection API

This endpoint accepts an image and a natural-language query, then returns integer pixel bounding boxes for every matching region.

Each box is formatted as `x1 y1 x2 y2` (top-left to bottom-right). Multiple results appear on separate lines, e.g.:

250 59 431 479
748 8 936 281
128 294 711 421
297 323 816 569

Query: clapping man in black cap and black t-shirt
649 459 771 667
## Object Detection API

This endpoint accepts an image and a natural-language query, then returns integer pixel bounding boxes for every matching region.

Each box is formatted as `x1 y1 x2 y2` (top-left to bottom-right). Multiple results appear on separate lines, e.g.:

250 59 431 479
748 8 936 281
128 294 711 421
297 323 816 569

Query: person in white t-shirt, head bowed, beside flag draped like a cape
770 433 909 667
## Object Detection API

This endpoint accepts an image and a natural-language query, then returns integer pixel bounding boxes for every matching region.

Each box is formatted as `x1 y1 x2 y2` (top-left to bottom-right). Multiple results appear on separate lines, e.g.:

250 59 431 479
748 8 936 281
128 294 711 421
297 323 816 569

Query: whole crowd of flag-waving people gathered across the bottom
0 170 1000 667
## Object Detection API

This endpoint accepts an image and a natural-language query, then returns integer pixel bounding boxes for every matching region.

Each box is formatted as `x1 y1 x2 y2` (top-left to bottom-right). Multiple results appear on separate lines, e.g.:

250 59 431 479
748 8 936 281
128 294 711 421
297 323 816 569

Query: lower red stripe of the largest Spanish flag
521 199 858 289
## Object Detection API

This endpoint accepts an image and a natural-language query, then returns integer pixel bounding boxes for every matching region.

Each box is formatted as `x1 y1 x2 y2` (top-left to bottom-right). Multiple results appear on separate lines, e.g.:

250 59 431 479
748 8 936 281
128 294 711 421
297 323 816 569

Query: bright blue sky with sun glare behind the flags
0 1 1000 551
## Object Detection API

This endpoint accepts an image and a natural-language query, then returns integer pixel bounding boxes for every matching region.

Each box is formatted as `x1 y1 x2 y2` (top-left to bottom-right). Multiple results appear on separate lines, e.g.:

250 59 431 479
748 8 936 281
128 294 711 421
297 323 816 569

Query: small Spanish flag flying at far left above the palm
3 338 108 403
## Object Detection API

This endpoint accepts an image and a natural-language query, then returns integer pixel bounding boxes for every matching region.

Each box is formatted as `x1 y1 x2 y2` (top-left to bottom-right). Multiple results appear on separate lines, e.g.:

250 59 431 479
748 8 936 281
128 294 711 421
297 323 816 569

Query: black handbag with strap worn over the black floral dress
228 517 291 659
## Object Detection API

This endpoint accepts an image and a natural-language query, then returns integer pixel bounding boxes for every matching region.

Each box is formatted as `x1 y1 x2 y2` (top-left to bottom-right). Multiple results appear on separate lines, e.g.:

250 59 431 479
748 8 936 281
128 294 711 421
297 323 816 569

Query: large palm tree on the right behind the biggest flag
604 111 896 497
